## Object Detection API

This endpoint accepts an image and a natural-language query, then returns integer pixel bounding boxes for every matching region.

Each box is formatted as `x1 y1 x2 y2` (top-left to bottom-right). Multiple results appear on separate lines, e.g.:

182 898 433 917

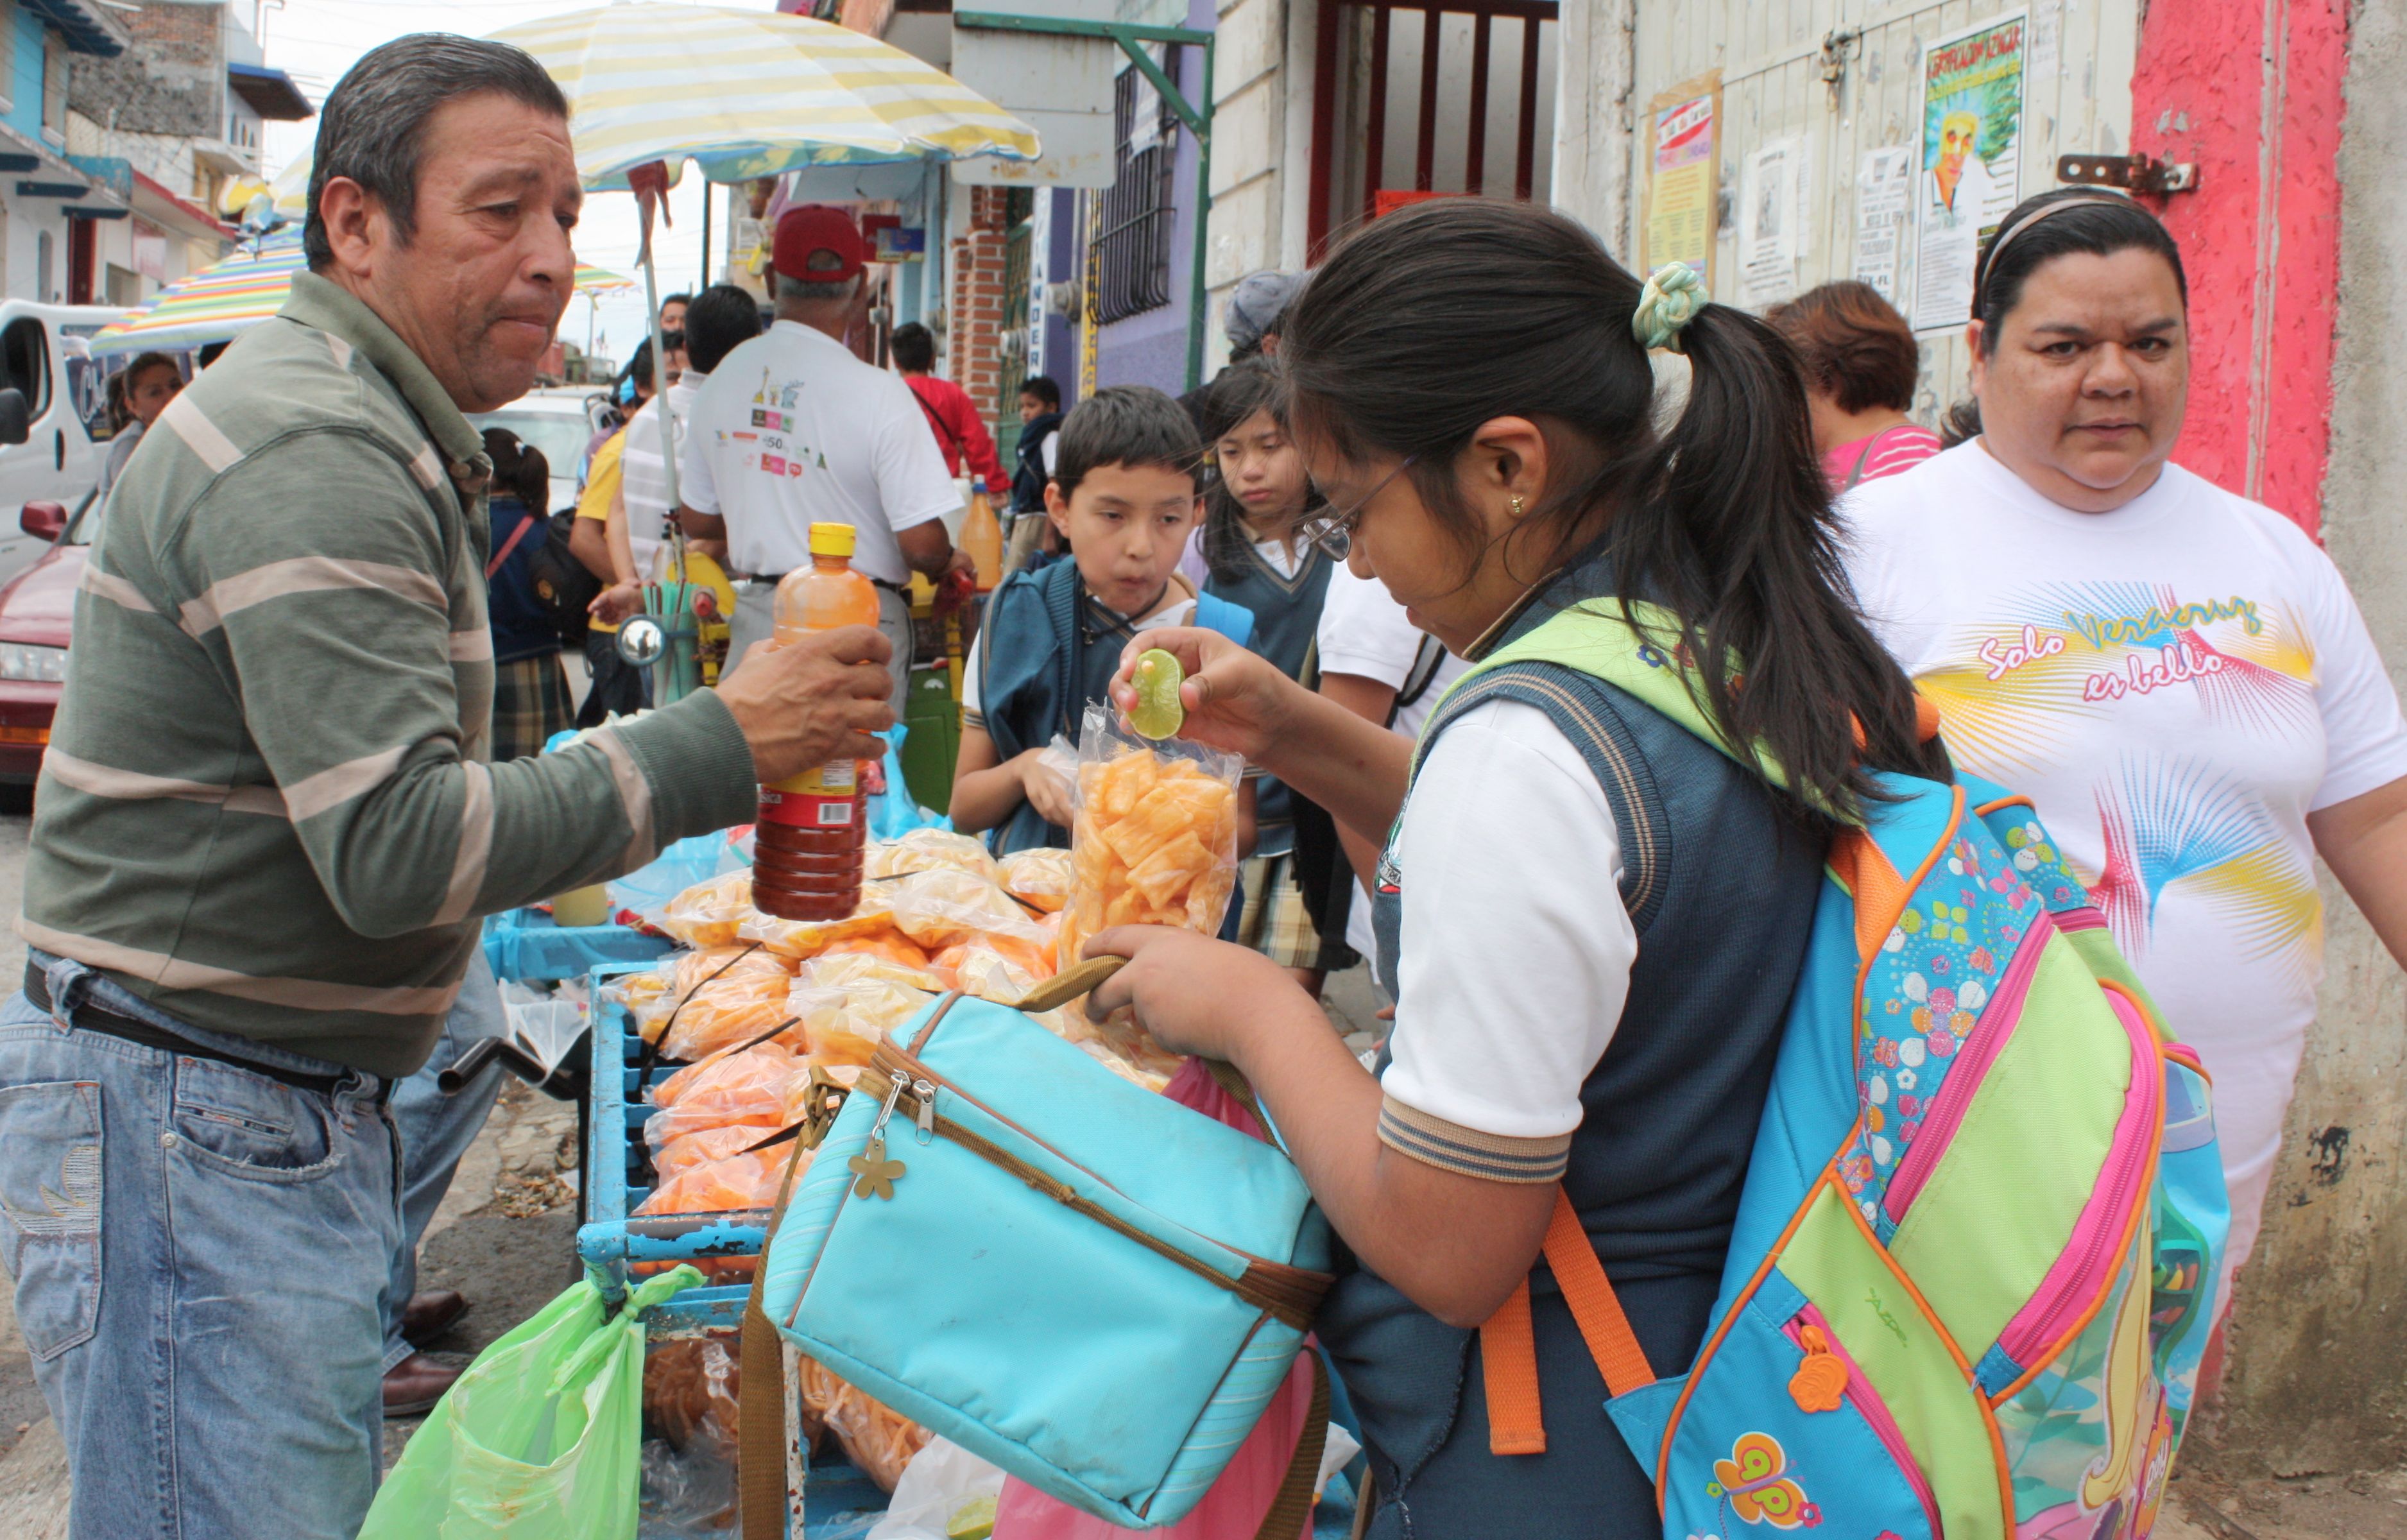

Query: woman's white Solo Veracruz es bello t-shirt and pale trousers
1842 440 2407 1266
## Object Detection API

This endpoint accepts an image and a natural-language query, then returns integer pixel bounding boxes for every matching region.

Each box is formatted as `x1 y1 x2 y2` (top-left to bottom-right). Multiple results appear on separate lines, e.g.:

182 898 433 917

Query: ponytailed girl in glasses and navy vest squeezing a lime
1090 198 1948 1540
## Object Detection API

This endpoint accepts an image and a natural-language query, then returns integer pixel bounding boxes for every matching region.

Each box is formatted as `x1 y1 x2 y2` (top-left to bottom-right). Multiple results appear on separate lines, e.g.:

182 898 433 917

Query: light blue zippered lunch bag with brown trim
746 958 1331 1536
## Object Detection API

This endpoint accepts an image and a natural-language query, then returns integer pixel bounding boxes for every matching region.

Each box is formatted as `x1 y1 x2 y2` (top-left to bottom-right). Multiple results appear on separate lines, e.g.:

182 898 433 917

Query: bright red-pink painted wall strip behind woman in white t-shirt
2132 0 2349 532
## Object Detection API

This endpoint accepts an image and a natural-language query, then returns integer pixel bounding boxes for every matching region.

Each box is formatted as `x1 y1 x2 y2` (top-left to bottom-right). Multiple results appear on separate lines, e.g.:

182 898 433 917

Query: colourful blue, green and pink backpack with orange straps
1434 604 2229 1540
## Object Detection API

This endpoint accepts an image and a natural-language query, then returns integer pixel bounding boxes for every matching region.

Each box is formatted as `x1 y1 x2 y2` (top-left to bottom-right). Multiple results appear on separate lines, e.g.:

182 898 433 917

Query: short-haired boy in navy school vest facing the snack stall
951 385 1254 854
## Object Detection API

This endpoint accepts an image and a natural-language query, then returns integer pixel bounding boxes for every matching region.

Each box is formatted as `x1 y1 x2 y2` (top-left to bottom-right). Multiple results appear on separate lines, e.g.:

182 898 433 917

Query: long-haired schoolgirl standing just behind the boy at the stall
1189 354 1336 998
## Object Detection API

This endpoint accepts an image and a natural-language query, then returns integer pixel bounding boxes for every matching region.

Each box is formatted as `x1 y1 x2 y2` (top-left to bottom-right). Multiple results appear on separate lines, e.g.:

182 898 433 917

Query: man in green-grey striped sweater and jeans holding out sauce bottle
0 36 891 1540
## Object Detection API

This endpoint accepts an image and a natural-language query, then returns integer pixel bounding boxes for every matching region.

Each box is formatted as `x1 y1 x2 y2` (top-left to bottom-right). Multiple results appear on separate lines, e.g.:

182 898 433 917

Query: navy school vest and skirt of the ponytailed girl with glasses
1319 561 1822 1540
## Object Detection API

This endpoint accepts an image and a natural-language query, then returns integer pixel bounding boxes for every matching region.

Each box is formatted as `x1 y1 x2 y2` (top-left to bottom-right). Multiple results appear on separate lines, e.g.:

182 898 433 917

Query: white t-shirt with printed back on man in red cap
676 320 961 585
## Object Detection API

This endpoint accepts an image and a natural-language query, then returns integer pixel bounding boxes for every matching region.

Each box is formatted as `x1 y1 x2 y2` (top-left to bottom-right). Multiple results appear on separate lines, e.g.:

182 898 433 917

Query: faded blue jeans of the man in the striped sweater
0 953 407 1540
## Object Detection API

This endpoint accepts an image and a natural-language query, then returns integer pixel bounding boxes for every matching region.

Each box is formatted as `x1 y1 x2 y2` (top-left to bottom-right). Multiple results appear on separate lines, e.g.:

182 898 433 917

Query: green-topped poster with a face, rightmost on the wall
1909 12 2025 332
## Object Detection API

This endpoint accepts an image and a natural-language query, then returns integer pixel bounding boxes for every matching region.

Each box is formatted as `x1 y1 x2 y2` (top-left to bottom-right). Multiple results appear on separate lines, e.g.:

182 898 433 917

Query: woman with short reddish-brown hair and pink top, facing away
1764 279 1940 491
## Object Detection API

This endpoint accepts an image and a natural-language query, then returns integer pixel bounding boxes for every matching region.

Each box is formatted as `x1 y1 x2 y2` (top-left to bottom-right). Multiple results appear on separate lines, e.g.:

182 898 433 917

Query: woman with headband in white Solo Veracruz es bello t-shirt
1842 190 2407 1299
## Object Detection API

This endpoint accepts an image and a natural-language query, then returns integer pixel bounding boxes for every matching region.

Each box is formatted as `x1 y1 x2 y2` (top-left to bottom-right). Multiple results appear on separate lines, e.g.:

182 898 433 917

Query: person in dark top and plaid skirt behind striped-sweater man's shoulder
484 429 575 766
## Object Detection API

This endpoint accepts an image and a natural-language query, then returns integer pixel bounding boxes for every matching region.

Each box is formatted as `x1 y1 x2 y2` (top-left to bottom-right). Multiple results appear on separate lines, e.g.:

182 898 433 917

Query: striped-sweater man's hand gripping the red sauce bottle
720 626 895 785
